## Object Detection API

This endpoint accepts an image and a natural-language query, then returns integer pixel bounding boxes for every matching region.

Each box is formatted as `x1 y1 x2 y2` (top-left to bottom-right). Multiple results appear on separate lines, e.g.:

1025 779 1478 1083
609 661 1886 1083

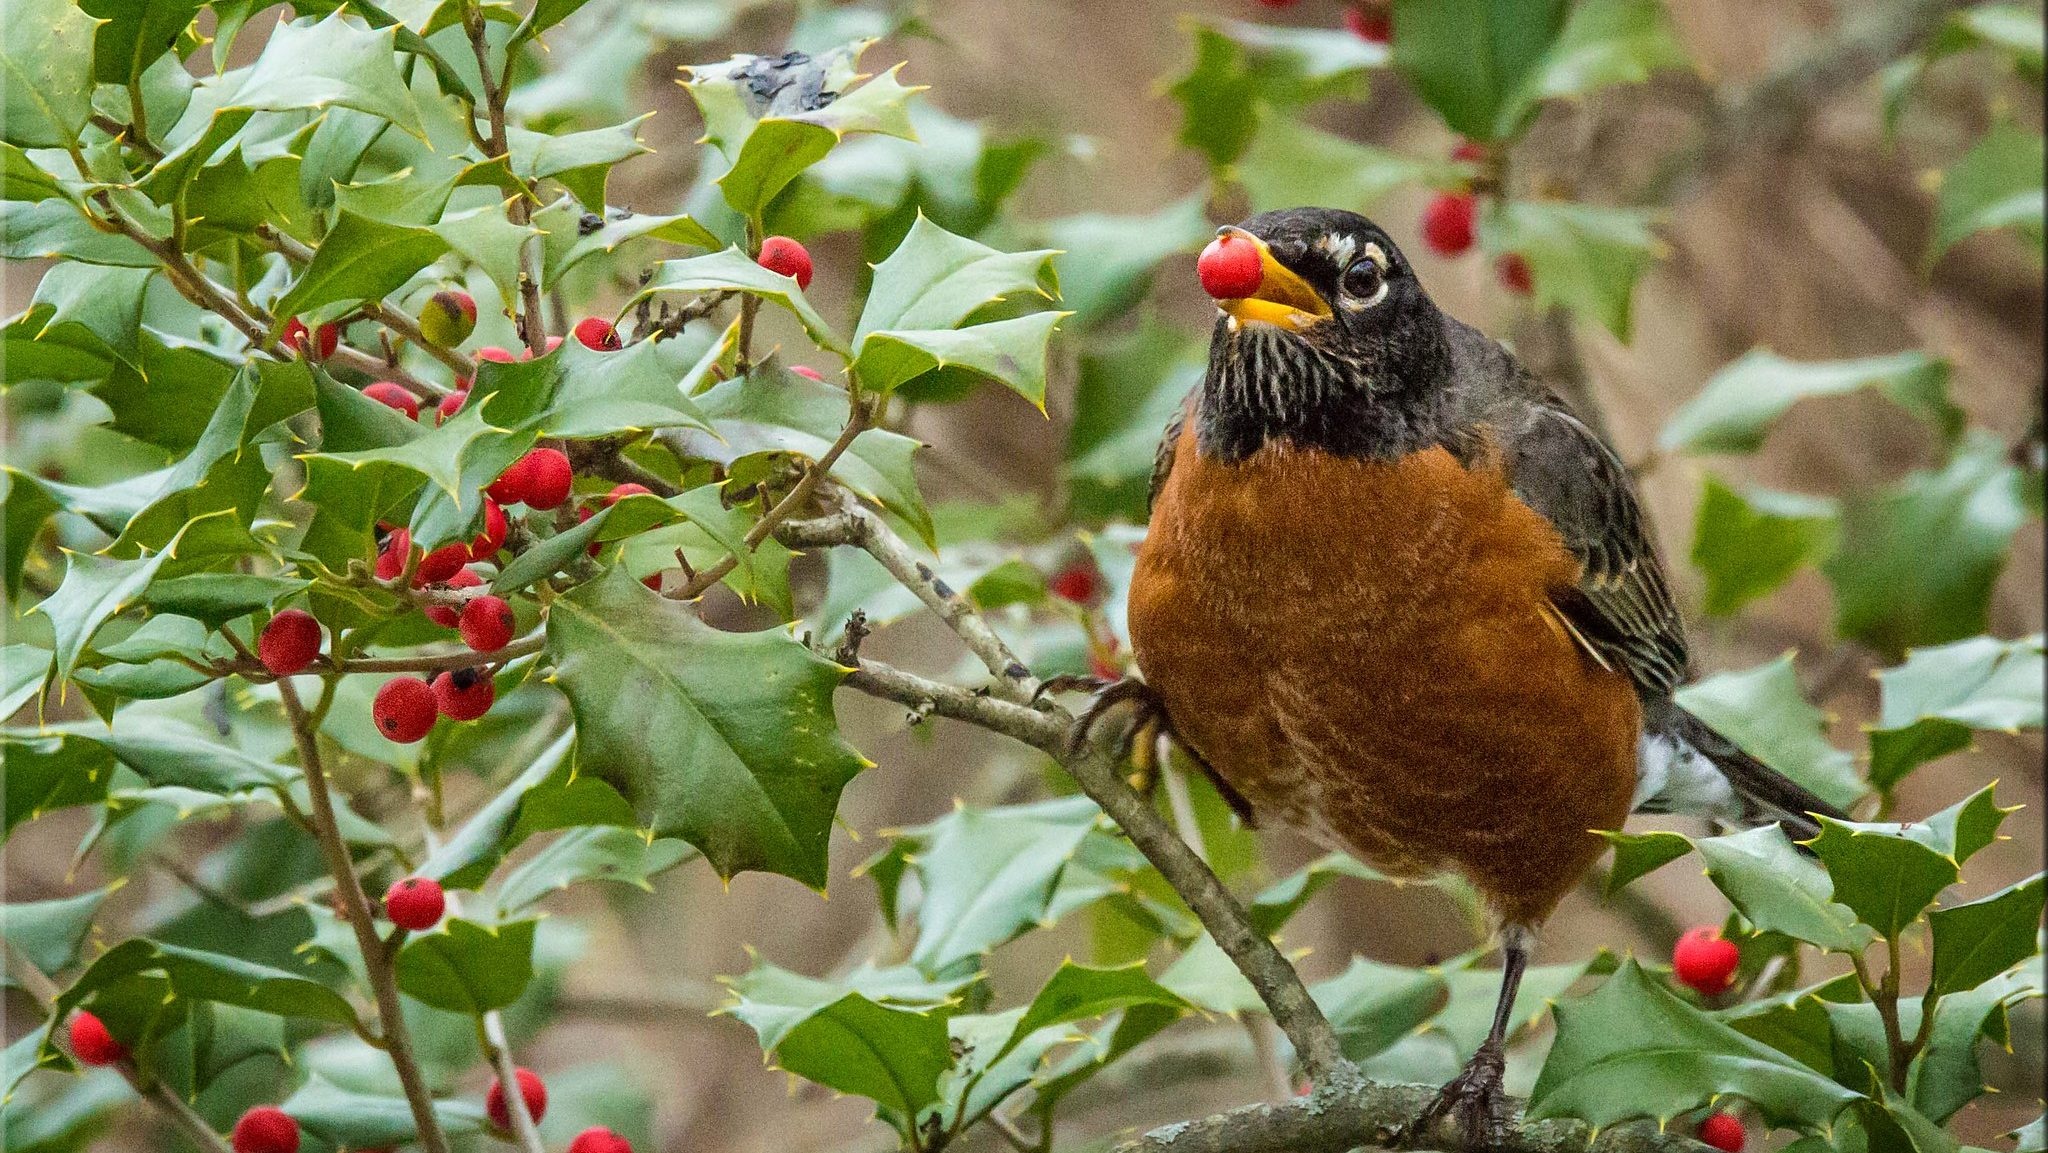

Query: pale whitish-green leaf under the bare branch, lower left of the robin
899 797 1102 973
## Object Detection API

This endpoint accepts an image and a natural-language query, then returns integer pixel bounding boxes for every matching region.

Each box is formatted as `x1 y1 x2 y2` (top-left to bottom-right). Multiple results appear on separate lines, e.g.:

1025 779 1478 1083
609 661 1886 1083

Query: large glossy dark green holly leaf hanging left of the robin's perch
547 565 864 889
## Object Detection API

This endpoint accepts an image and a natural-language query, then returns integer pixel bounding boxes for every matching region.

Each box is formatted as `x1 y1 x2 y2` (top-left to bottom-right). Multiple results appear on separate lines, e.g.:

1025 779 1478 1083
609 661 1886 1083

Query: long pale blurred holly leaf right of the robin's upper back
1657 348 1962 453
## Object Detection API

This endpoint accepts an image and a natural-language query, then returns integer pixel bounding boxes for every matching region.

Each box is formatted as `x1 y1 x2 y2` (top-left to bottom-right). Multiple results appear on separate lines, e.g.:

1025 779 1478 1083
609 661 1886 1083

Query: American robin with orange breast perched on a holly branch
1102 209 1841 1141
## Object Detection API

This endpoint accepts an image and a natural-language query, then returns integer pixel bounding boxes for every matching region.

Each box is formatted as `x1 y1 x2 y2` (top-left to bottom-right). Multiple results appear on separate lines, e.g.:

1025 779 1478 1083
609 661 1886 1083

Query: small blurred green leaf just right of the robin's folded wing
1692 475 1841 616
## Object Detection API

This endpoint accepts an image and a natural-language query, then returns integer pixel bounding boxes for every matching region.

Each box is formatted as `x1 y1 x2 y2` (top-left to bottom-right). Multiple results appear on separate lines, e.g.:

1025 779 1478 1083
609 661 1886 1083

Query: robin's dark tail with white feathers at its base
1636 704 1849 840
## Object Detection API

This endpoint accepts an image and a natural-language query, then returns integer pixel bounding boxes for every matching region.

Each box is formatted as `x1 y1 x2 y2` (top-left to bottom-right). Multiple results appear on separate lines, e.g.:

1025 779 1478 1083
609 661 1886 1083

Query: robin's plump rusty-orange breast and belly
1130 420 1640 926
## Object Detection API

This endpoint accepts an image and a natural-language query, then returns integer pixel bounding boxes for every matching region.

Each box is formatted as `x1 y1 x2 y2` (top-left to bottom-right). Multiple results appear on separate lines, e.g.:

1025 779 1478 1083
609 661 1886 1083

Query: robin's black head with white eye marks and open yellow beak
1198 209 1452 461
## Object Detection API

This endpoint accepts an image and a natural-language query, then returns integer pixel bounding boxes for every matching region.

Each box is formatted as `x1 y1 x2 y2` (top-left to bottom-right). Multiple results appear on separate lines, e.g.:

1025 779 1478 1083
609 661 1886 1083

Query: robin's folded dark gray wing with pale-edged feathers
1497 399 1688 698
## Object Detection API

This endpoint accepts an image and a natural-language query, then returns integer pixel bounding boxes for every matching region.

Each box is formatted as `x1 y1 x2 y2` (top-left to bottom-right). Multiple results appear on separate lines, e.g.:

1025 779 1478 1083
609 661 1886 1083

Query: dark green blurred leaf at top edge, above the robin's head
1393 0 1565 141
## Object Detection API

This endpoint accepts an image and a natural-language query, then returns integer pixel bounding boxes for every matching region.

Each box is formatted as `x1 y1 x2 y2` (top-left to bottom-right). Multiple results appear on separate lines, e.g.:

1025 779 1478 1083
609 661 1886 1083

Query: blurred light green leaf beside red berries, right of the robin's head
1482 199 1665 340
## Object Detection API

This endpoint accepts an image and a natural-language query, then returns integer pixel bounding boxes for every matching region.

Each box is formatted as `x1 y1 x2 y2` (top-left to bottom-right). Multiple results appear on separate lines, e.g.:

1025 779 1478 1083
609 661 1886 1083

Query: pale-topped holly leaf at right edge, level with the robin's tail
1870 633 2042 793
